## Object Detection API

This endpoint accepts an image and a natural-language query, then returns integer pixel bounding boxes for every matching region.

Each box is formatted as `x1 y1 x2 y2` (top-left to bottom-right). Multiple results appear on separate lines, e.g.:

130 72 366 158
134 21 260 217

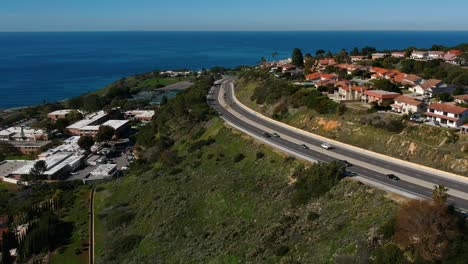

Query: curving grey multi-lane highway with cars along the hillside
209 78 468 211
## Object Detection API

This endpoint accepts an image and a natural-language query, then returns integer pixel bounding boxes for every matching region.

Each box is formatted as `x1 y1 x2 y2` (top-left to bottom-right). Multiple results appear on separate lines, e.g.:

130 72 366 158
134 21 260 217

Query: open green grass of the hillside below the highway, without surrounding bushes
92 120 396 263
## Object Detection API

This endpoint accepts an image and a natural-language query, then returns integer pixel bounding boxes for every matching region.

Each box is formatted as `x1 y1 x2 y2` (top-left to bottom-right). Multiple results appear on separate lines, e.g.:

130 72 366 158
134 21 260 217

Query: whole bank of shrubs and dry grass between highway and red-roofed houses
236 70 468 176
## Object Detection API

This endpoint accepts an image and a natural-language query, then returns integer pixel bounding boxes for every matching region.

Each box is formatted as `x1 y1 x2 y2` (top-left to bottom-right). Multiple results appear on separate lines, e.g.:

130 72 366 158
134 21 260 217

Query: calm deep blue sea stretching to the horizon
0 31 468 108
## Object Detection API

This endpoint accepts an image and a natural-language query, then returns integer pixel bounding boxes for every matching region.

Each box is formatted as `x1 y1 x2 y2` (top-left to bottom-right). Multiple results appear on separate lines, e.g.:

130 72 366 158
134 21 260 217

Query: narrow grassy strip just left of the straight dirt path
51 188 90 264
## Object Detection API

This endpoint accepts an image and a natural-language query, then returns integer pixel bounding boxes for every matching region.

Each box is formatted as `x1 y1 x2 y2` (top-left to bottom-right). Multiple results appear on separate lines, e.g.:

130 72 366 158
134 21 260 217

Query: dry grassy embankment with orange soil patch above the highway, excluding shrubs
237 79 468 176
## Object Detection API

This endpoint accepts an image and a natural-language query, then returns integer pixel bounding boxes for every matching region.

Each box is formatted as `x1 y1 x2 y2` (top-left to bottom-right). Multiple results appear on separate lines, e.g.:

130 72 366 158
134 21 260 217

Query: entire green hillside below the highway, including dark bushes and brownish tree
90 73 466 263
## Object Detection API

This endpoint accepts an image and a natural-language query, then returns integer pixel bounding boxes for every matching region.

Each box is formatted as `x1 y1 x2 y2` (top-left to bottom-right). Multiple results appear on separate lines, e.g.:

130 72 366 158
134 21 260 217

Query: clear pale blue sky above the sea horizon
0 0 468 31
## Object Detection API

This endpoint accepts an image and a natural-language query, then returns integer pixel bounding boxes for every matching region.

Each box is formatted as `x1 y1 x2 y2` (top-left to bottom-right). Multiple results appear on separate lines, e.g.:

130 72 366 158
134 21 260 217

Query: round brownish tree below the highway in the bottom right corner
394 200 460 262
